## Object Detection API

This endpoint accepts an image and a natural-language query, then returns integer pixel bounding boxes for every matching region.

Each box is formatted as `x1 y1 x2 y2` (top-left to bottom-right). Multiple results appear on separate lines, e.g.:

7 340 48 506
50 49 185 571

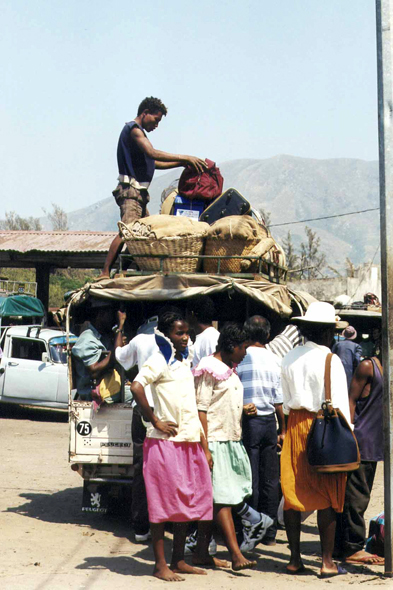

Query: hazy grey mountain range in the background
42 155 379 270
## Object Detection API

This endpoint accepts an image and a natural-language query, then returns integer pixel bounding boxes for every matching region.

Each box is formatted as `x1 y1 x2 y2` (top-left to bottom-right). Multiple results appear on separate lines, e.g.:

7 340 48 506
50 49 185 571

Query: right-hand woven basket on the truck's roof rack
203 237 260 274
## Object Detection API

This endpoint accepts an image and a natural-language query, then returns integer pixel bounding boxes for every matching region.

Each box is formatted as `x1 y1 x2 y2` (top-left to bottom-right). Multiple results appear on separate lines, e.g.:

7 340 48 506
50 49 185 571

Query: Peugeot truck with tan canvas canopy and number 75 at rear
66 247 309 513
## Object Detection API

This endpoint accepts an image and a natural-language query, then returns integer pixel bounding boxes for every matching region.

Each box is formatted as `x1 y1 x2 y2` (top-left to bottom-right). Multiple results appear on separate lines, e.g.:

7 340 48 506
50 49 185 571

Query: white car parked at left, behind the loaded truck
0 326 77 409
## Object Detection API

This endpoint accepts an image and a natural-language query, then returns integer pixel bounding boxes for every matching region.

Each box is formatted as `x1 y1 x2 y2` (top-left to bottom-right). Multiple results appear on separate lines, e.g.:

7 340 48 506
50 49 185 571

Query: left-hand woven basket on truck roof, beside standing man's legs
119 223 205 272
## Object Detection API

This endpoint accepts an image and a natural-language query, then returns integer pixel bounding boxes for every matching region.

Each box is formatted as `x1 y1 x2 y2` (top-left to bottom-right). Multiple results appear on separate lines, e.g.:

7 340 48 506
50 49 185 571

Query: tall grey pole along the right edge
376 0 393 577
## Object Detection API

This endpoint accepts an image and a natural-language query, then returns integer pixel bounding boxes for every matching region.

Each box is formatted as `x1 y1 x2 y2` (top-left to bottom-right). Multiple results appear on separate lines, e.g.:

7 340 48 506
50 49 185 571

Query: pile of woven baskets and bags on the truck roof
119 160 285 274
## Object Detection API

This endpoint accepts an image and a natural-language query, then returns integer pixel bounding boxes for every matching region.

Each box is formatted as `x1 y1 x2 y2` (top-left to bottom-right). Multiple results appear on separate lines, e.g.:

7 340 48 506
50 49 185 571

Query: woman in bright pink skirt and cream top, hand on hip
131 312 213 581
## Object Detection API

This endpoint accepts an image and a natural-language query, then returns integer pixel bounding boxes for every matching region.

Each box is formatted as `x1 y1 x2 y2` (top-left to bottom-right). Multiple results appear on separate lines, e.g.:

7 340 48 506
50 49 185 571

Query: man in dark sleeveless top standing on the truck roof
99 96 207 279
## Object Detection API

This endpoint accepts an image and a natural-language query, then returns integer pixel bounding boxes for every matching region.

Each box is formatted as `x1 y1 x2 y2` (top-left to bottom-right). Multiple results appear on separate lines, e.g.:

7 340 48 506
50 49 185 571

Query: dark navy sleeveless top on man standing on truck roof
117 121 156 182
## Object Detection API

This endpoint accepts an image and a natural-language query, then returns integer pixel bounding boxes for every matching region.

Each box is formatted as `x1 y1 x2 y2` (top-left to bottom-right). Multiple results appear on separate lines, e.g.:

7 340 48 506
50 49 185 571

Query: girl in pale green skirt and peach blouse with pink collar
193 323 273 571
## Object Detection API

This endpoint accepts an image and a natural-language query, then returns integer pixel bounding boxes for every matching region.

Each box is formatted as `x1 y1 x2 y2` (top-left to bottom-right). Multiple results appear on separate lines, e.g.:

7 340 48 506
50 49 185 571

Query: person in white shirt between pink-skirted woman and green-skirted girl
187 297 220 367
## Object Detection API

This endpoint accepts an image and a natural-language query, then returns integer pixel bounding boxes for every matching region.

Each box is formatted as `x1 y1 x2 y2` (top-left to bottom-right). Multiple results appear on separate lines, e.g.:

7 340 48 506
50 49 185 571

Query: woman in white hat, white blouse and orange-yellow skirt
281 301 351 578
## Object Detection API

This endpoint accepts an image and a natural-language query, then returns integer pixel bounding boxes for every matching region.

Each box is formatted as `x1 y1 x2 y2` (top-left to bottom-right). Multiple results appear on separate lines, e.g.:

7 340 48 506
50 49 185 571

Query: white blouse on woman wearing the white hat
281 341 351 424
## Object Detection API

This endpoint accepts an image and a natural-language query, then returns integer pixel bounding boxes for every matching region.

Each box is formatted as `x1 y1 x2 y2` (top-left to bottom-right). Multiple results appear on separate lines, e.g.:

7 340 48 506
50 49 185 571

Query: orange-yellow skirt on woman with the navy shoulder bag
281 410 347 512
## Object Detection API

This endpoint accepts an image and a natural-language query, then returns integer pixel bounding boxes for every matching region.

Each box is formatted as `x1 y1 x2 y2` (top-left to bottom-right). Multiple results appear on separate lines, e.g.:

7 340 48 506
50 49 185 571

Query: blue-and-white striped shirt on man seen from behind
236 346 283 416
